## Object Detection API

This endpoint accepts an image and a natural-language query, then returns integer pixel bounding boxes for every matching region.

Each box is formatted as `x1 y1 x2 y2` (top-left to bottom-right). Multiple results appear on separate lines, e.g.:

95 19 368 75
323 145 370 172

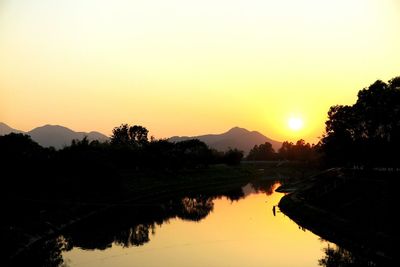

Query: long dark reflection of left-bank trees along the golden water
15 181 275 266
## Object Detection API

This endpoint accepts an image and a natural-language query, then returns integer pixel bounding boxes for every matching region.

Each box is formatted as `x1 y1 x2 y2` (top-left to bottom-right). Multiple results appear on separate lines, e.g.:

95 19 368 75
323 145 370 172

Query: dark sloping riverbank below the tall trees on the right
279 169 396 266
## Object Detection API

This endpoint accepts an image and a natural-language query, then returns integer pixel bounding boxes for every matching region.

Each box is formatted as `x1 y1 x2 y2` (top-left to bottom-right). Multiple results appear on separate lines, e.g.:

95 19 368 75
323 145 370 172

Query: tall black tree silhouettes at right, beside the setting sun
320 77 400 166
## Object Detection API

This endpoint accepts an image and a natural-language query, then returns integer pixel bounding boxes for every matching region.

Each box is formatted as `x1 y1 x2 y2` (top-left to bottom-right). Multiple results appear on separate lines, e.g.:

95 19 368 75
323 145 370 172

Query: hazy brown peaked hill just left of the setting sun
168 127 282 154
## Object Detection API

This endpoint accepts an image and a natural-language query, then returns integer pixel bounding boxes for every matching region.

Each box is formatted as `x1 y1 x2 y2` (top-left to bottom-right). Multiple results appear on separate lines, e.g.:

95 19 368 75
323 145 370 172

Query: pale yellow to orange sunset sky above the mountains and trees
0 0 400 143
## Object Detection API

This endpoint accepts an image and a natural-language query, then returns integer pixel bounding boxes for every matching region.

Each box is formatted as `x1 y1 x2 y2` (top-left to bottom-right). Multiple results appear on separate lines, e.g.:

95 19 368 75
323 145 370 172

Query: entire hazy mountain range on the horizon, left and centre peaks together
0 122 282 154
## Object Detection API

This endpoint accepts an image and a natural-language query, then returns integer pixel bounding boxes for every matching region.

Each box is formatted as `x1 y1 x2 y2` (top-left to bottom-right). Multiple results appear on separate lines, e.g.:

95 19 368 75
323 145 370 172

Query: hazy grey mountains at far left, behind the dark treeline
0 122 108 149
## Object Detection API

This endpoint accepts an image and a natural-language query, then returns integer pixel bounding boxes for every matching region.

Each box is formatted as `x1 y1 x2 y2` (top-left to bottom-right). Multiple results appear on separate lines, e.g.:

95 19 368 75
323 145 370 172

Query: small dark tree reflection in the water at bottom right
318 245 377 267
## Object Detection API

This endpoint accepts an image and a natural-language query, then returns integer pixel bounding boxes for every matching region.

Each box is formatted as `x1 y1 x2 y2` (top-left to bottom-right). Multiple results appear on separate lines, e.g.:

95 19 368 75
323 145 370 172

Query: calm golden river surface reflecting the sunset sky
62 183 333 267
